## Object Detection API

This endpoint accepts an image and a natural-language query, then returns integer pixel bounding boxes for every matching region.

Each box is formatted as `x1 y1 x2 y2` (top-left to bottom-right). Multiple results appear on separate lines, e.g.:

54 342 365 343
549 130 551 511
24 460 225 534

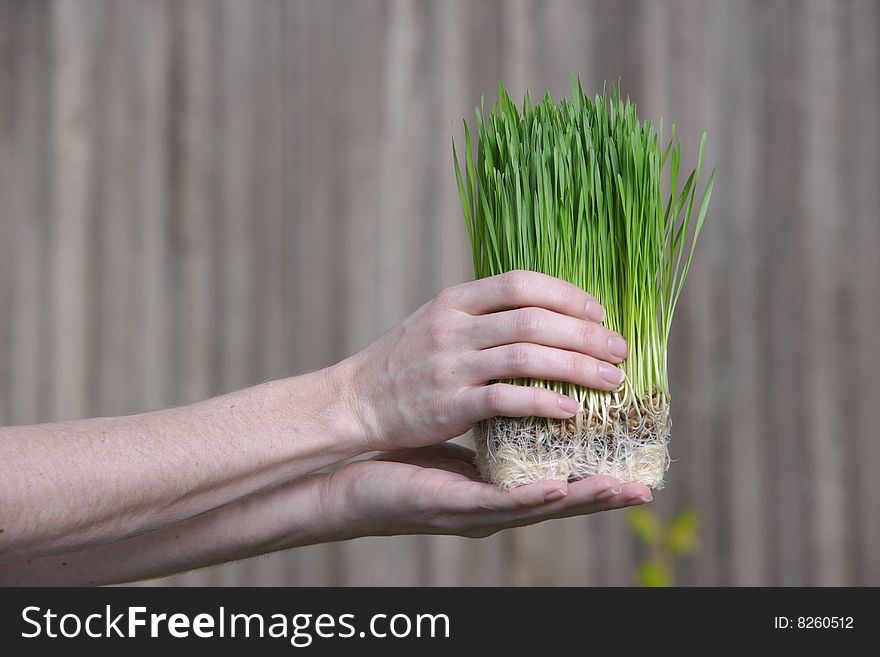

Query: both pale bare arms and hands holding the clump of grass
0 271 651 585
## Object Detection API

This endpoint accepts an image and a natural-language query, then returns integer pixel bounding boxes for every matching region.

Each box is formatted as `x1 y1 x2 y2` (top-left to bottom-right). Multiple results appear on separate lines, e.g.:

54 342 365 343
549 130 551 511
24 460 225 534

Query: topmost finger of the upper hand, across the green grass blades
447 269 605 322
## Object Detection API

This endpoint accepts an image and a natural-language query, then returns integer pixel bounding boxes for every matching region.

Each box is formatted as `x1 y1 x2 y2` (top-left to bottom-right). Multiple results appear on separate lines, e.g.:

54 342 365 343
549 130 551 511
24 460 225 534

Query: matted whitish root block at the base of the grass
474 404 672 490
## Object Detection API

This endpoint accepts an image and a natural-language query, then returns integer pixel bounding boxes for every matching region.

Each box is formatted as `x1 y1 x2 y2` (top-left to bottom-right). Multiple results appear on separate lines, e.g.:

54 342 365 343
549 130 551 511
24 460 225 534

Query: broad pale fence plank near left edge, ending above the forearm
50 0 107 419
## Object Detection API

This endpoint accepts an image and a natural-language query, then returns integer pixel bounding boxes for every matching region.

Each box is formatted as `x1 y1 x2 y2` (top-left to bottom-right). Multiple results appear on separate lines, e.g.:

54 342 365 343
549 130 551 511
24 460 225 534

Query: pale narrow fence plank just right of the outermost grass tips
712 4 768 586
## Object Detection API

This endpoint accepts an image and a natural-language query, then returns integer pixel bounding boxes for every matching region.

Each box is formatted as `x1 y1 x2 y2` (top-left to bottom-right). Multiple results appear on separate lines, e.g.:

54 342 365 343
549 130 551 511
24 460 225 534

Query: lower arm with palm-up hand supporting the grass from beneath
0 443 651 586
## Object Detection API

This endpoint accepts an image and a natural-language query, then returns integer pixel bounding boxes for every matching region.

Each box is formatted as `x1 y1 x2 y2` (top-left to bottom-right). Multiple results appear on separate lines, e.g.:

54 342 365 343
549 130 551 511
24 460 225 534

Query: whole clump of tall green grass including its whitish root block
453 77 715 490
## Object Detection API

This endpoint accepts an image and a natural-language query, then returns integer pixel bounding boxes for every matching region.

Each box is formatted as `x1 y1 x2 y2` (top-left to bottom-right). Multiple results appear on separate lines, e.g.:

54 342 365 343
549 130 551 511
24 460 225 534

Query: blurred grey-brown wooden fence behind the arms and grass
0 0 880 585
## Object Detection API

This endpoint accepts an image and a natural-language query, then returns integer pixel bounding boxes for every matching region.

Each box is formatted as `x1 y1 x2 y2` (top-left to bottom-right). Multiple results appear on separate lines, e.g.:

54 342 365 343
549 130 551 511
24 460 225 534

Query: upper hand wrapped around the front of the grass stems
337 271 627 449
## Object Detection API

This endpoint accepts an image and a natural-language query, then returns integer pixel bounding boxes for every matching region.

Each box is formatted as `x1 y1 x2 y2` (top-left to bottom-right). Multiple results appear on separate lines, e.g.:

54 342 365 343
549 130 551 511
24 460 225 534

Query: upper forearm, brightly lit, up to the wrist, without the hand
0 363 364 561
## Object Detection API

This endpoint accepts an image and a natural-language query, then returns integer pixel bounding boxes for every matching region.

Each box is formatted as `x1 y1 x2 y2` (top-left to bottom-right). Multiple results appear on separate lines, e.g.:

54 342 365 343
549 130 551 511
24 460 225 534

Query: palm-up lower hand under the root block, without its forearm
321 443 652 538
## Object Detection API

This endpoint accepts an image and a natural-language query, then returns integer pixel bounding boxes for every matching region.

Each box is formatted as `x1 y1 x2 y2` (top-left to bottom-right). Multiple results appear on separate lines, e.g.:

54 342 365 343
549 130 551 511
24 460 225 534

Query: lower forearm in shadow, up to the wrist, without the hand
0 468 354 586
